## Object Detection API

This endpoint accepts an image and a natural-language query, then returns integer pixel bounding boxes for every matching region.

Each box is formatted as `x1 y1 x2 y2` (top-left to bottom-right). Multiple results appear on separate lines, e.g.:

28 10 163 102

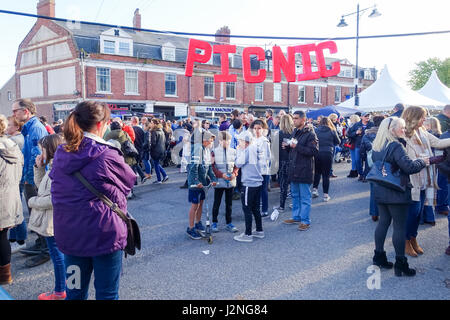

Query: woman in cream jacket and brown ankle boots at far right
402 106 450 257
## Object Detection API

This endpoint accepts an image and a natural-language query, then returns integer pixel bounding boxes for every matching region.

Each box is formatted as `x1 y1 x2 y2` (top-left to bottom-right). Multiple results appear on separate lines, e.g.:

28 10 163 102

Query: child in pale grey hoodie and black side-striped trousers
234 132 264 242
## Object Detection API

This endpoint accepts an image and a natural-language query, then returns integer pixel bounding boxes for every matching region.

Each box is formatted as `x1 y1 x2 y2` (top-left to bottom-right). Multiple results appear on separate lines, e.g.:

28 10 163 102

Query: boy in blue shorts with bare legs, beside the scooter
186 129 217 240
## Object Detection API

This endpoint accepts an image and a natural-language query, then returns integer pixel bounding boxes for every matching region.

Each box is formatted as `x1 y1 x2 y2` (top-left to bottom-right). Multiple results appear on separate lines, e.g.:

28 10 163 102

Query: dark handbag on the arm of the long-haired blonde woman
366 146 406 192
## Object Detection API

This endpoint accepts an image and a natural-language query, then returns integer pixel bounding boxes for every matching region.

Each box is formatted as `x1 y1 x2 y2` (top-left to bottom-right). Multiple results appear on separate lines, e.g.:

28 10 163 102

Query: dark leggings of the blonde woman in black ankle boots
375 203 409 257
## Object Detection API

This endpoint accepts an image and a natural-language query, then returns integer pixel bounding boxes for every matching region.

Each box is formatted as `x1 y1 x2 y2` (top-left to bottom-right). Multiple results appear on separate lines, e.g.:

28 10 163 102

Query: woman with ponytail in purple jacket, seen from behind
50 101 136 300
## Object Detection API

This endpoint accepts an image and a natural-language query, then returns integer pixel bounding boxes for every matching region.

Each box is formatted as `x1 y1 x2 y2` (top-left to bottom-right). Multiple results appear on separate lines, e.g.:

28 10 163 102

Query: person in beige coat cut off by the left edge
0 114 23 285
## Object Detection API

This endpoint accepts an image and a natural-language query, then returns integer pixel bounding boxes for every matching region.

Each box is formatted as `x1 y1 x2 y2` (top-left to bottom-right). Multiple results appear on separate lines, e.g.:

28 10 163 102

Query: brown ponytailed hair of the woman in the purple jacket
64 101 111 152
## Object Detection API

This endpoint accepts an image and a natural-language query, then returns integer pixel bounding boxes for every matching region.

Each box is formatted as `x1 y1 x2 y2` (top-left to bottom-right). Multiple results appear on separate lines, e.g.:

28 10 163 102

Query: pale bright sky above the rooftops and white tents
0 0 450 87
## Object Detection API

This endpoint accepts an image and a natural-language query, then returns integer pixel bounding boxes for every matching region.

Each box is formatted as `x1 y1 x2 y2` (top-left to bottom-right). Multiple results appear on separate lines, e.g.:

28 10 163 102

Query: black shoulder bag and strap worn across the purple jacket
74 171 141 258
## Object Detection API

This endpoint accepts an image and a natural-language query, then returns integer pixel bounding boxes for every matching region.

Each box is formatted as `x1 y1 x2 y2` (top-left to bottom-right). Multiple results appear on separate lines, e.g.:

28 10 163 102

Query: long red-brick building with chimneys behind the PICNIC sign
15 0 376 119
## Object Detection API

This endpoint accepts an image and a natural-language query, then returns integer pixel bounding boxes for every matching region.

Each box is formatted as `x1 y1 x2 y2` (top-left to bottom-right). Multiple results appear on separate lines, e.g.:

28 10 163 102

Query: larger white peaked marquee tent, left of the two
338 66 445 112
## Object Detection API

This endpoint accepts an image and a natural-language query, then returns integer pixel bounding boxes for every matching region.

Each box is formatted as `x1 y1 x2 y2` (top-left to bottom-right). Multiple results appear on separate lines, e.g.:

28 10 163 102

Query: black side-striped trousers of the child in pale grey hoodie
241 186 263 236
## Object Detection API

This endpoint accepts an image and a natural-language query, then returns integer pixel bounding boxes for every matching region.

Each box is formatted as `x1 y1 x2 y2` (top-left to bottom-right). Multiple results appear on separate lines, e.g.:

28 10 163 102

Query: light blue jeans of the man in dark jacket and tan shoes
291 182 311 224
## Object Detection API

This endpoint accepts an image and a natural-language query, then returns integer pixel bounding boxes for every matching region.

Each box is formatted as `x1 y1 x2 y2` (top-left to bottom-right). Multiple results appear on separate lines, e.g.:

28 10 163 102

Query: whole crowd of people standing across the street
0 99 450 300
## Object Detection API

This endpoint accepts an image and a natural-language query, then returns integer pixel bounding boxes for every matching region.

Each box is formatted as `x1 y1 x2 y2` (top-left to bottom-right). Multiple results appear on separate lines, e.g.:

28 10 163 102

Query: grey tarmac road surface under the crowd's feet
4 163 450 300
